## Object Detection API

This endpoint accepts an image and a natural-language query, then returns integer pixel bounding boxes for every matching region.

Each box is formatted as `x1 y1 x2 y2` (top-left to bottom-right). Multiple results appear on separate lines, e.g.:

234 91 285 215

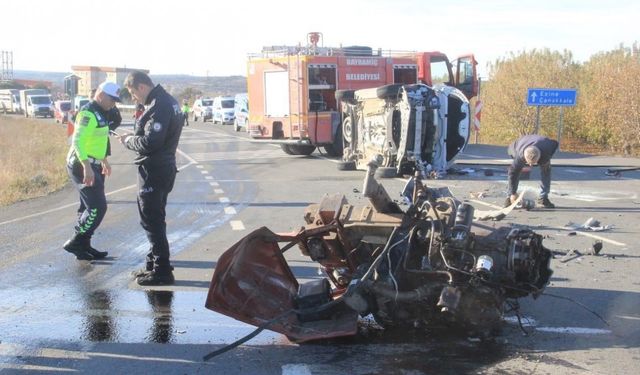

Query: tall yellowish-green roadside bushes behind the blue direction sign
480 43 640 156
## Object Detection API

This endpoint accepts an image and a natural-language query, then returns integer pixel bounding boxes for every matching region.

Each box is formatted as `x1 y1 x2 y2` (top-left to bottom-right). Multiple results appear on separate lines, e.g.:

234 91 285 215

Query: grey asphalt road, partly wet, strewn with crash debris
0 117 640 374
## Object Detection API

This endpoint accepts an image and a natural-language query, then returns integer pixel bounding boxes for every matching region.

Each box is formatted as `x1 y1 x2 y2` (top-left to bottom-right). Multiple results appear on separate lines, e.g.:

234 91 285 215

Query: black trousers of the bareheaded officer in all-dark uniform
138 164 176 272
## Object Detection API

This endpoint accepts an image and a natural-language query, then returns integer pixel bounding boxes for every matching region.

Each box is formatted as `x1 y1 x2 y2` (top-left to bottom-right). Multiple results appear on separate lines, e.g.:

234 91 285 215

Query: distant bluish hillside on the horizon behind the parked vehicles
13 70 247 96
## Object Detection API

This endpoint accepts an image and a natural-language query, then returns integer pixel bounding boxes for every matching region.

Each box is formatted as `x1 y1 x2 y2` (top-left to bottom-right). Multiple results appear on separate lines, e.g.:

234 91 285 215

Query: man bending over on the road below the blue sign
504 134 558 208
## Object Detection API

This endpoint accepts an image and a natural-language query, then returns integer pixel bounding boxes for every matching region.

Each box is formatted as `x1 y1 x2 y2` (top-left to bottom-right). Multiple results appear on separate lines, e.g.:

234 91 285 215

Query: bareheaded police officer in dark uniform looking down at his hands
118 71 184 285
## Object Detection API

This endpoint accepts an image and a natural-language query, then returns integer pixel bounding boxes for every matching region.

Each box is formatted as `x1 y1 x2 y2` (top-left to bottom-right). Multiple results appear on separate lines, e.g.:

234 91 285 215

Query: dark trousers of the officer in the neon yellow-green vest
67 160 107 238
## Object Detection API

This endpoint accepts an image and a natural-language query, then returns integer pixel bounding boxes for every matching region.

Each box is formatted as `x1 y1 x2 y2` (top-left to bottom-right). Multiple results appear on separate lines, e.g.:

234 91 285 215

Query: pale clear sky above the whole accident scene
0 0 640 76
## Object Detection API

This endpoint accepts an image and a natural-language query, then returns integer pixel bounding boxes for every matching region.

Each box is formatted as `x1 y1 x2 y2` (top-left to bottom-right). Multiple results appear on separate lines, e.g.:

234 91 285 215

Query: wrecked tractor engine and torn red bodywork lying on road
206 162 552 342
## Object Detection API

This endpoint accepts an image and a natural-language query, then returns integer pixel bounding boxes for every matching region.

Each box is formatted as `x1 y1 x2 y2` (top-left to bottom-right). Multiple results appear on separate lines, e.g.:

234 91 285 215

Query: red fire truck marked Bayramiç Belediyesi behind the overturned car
247 32 478 156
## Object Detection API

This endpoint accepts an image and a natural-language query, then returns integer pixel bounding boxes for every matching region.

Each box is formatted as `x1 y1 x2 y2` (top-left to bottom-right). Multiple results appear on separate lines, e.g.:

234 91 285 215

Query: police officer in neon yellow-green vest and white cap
63 82 120 260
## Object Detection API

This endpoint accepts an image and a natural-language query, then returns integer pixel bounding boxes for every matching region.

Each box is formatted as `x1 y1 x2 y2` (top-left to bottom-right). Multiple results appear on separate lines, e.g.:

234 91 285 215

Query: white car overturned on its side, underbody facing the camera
336 84 470 177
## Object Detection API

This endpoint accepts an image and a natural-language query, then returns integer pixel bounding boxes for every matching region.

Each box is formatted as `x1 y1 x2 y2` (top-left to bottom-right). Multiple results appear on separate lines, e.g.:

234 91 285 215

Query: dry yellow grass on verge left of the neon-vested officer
0 115 69 206
